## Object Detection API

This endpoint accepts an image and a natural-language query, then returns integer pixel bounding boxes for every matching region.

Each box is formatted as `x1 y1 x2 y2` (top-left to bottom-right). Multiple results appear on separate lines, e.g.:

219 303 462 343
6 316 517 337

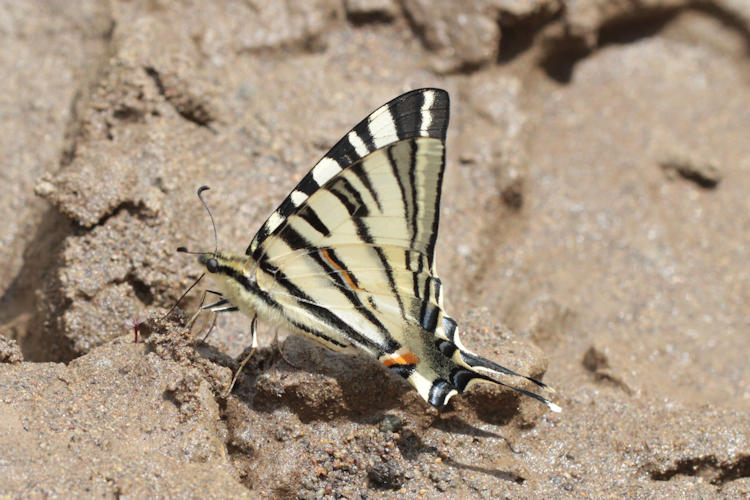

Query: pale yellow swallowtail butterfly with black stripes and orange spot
183 88 560 411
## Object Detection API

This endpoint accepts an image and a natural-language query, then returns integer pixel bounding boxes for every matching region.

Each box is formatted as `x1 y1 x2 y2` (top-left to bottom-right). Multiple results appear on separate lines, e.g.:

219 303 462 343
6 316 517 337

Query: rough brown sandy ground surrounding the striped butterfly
0 0 750 499
